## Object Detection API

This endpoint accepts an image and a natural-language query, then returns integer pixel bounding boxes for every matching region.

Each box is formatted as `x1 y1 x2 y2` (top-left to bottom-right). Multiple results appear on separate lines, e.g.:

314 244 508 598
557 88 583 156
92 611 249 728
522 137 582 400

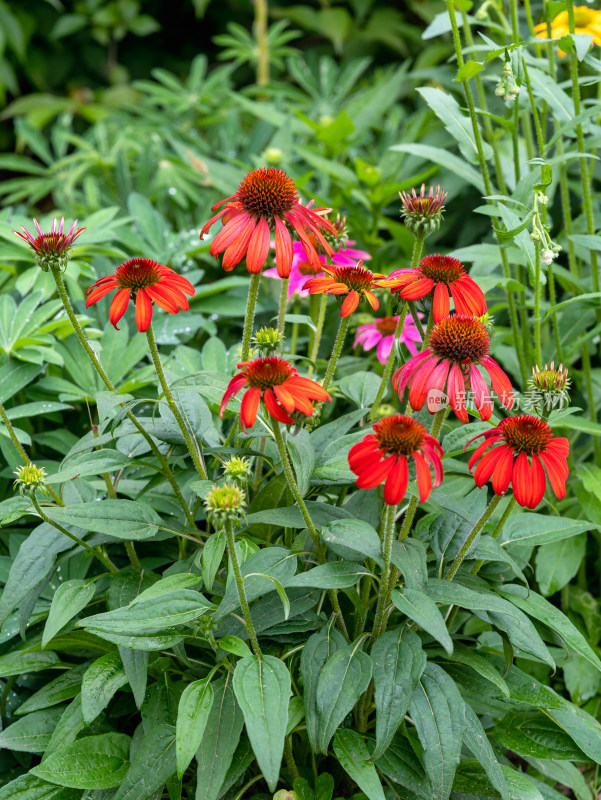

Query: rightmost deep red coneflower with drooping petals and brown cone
466 414 570 508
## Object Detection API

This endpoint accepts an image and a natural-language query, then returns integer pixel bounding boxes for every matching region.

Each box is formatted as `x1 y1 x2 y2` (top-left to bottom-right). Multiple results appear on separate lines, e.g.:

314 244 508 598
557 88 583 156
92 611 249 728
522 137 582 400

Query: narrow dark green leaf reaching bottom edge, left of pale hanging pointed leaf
196 673 244 800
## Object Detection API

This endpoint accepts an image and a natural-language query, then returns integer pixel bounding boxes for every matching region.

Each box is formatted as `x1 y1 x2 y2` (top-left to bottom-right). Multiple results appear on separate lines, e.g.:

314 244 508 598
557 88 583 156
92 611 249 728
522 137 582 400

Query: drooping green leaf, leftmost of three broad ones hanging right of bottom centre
315 644 372 754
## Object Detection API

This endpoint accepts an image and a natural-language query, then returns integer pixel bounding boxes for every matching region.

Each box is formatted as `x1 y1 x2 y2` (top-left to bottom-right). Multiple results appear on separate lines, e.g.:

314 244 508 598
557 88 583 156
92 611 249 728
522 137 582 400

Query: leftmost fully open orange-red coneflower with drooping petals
86 258 194 333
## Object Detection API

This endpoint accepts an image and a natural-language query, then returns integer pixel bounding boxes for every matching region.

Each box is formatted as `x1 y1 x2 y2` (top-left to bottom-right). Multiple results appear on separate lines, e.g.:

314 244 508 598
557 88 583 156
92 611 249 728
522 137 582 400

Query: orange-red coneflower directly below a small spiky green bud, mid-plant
219 356 332 430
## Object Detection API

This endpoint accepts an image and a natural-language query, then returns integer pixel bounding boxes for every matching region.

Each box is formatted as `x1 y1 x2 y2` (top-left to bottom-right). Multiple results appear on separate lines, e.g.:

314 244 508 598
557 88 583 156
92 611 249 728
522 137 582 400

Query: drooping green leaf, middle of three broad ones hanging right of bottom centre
371 628 426 760
